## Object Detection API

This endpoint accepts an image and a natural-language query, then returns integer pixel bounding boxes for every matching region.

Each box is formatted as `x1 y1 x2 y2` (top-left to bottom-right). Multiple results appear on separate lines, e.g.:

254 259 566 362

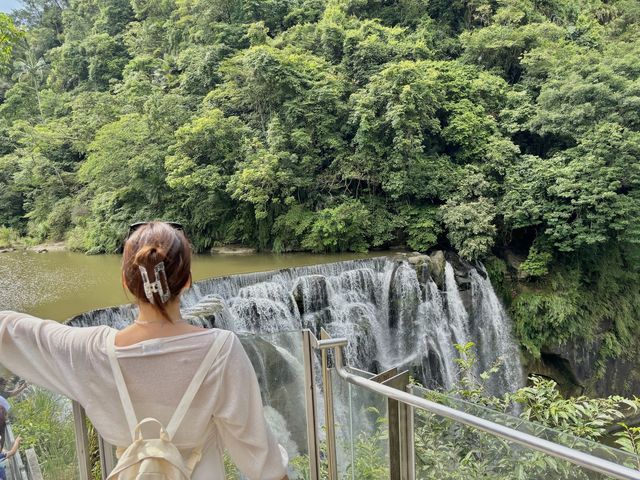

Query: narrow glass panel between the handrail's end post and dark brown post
332 369 389 480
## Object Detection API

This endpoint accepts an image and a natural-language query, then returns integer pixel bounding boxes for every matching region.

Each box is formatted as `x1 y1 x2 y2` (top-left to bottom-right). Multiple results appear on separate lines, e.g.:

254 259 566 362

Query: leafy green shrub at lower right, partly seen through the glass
414 343 640 480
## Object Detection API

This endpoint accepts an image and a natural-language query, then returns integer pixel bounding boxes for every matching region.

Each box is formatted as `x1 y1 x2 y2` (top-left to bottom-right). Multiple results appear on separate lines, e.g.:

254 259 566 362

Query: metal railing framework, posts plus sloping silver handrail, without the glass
22 330 640 480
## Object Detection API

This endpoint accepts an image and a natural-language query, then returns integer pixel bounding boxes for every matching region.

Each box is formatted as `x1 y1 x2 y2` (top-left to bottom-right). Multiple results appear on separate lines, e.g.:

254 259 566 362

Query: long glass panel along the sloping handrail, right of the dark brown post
412 386 638 480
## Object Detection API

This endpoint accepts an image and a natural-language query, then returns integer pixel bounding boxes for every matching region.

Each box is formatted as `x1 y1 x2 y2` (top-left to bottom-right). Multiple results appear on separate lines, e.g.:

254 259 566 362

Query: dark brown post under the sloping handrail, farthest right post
381 371 409 480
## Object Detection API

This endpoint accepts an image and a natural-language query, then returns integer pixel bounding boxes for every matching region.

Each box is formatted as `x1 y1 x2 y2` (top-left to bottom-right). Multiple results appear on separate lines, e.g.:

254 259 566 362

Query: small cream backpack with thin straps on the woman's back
107 332 231 480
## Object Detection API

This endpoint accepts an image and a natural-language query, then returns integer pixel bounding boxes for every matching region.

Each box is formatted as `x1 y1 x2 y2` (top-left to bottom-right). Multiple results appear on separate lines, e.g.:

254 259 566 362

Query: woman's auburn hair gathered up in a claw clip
122 222 191 321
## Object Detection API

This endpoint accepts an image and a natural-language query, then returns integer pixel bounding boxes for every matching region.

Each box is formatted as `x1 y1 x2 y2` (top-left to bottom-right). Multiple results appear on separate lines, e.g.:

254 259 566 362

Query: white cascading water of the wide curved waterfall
70 257 524 468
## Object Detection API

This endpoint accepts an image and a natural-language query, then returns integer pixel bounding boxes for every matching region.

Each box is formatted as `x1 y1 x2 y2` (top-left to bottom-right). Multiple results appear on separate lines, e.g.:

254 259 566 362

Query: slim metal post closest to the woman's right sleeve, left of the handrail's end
302 330 320 480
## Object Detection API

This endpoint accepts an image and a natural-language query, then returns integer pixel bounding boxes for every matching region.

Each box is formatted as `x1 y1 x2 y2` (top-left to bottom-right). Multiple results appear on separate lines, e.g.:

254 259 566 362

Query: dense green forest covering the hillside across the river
0 0 640 368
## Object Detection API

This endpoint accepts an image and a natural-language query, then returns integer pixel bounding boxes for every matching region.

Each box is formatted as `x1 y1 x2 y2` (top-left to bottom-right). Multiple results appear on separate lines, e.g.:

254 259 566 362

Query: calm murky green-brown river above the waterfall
0 251 389 321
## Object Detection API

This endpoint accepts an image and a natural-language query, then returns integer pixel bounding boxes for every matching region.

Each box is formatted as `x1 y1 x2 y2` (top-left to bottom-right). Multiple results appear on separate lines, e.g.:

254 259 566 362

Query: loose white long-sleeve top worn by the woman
0 311 287 480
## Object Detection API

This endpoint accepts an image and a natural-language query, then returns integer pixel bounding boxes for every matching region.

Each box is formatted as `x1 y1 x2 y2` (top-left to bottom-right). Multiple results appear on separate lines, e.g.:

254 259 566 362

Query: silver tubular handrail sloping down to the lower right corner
332 338 640 480
